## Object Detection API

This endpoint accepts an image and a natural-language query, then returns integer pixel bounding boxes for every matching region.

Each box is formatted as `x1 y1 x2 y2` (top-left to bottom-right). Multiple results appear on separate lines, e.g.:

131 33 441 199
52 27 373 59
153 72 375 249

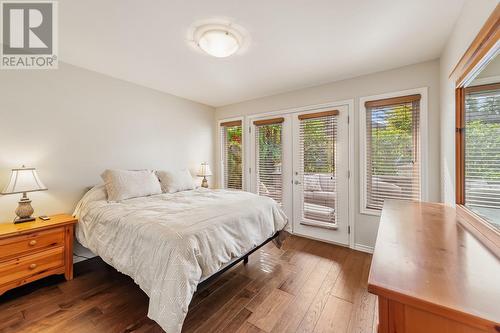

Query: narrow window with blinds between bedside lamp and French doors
220 120 243 190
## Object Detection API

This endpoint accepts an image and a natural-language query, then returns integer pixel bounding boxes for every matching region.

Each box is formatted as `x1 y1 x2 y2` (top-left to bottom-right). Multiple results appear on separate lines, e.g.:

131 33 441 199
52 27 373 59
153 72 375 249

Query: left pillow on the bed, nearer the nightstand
101 170 161 201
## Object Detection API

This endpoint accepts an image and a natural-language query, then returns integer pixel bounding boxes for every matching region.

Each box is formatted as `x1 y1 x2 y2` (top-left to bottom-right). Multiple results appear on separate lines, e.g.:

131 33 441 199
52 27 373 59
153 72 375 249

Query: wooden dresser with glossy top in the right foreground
368 200 500 333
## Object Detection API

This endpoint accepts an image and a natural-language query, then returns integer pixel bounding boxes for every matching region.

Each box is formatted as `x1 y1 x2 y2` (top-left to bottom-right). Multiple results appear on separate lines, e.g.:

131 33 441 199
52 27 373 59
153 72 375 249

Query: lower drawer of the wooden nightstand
0 246 64 285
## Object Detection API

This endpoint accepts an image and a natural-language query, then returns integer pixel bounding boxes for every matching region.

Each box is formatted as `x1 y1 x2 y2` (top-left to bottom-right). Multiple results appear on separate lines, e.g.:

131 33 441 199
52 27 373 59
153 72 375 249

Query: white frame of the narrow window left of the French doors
216 117 247 191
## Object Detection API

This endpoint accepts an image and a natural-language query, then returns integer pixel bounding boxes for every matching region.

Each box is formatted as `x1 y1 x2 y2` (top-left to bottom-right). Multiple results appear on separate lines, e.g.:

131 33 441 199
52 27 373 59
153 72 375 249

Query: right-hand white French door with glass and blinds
293 107 349 244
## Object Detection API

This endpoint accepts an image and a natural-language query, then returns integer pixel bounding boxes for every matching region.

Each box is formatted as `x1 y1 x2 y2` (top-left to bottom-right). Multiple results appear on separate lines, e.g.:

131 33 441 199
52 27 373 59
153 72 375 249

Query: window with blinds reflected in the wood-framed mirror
465 84 500 230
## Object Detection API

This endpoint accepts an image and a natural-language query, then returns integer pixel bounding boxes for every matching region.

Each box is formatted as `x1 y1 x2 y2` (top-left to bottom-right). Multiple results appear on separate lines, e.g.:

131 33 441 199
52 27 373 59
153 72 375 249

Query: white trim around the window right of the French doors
359 87 429 216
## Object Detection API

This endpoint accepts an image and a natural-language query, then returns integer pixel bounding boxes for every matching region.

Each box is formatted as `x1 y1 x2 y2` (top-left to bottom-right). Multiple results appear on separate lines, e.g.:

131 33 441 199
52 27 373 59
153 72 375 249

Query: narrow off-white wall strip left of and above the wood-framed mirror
440 0 498 205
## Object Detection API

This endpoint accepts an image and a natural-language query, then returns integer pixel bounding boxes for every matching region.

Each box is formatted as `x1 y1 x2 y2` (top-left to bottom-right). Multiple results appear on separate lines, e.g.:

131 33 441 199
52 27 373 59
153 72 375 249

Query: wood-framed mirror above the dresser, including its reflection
450 6 500 252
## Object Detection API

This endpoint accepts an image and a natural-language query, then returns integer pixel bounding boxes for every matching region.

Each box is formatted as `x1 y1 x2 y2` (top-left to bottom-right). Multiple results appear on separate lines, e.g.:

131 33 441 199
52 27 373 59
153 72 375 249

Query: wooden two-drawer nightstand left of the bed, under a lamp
0 215 77 295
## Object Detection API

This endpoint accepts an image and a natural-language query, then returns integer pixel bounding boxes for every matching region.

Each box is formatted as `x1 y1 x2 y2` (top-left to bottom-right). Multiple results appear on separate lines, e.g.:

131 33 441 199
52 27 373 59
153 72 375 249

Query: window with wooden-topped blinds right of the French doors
365 94 421 210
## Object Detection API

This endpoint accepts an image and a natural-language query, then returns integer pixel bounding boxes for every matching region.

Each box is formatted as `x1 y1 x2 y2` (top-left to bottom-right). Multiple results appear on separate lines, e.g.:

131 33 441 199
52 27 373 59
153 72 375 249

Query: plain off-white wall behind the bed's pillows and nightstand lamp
0 64 214 222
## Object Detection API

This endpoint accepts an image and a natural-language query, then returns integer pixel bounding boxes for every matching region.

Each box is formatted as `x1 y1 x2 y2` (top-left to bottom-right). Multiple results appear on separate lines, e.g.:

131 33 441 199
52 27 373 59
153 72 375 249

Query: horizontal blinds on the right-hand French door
298 111 338 224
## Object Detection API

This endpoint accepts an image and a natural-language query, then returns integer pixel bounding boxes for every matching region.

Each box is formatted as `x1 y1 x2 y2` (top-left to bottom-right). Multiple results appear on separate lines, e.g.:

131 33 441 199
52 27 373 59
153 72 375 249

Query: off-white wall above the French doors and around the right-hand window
216 60 441 247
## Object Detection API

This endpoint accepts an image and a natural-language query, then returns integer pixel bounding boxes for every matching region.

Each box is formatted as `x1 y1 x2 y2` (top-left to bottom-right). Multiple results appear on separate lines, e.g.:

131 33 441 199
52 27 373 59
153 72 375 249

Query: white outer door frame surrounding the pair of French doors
243 99 356 249
